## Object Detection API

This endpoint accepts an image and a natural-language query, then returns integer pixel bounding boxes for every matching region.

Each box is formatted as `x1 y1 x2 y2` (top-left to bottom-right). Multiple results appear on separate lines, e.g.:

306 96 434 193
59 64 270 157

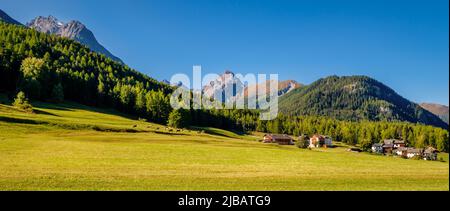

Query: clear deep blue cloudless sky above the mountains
0 0 449 105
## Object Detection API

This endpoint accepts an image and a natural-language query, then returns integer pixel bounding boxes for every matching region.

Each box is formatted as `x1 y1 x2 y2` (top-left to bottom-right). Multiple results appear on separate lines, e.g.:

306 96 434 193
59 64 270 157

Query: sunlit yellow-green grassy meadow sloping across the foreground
0 99 449 190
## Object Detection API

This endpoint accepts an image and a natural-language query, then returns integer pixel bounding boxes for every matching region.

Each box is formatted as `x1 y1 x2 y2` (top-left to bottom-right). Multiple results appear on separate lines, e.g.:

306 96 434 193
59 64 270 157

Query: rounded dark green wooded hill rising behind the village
279 76 448 128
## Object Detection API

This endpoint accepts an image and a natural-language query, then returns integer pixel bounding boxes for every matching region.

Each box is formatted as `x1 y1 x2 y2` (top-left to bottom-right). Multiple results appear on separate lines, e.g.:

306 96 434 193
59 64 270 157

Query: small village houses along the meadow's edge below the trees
262 134 439 160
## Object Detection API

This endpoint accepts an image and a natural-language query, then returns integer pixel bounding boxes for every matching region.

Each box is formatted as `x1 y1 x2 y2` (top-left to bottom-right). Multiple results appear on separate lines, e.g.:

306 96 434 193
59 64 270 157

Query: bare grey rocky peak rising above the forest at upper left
27 16 123 64
